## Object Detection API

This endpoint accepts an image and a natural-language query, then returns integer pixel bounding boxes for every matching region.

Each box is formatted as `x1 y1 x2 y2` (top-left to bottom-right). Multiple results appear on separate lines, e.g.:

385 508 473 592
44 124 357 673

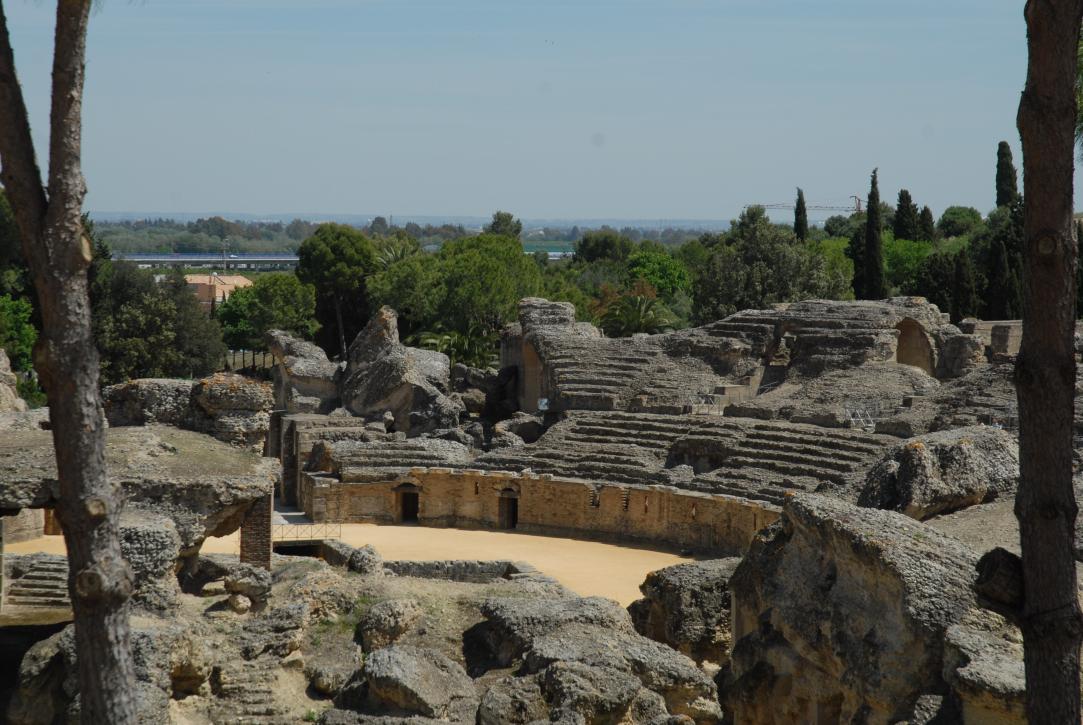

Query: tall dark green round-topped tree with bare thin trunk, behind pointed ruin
297 223 376 358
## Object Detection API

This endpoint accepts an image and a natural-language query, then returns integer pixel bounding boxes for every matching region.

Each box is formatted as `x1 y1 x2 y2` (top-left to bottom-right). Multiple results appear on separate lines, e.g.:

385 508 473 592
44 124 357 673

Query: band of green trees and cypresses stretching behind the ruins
0 142 1052 405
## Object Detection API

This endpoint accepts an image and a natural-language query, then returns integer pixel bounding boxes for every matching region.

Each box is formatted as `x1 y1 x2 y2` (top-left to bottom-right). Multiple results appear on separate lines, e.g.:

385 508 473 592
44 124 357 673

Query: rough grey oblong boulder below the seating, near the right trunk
858 426 1019 520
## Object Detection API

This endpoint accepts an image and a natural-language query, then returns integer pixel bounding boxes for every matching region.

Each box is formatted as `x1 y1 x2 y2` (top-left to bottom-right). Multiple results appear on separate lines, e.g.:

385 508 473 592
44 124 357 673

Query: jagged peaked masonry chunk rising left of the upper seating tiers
342 307 464 436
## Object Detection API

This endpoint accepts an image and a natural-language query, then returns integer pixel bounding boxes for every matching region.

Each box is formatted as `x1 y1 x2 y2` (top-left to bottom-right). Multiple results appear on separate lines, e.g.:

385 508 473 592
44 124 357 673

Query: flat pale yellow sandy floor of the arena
4 523 689 606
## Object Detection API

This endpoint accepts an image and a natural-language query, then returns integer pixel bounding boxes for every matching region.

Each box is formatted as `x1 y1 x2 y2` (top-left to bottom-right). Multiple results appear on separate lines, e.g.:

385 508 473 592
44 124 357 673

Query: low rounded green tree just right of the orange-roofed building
218 272 318 350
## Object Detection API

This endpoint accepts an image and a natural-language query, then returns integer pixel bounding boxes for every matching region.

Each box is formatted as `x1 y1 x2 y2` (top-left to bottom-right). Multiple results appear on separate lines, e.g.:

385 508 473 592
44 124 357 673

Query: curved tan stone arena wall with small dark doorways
300 468 779 553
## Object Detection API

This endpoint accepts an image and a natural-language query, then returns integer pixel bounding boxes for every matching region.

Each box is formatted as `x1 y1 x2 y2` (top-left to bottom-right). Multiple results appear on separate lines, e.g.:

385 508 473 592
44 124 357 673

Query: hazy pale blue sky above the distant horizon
5 0 1048 219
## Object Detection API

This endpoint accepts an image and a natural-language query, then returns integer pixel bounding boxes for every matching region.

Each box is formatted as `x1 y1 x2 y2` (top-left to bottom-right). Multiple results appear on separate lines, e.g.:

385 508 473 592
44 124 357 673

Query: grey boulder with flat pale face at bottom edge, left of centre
362 646 478 723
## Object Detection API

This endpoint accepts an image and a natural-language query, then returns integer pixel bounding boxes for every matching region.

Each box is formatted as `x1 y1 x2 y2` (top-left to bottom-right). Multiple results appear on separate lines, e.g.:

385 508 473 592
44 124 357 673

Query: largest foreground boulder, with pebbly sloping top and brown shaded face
719 494 978 723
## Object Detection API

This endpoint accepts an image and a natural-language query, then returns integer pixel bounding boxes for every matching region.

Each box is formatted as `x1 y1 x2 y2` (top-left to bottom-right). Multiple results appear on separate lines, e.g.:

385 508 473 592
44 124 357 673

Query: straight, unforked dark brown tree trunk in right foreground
1016 0 1083 725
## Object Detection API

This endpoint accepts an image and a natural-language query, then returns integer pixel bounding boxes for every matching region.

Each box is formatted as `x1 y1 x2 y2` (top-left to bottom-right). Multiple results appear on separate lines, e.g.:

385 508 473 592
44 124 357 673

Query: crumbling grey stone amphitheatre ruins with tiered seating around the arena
0 297 1052 725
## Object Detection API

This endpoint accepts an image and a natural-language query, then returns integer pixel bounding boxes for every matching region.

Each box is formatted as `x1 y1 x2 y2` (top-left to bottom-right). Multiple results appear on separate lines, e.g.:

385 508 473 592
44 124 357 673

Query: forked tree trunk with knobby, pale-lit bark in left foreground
0 0 135 723
